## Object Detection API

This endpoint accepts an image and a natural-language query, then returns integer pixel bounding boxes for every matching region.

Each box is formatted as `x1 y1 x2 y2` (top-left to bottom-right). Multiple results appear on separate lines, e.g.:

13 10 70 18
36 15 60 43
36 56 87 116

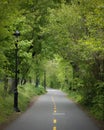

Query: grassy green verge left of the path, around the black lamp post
0 84 45 124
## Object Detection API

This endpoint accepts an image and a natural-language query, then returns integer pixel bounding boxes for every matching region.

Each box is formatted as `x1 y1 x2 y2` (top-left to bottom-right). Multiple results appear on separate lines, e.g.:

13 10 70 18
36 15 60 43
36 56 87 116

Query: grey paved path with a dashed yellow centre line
6 89 99 130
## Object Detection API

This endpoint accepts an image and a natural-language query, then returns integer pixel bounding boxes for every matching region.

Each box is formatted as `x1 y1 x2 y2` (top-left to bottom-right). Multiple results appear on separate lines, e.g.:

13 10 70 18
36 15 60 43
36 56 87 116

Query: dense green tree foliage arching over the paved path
0 0 104 119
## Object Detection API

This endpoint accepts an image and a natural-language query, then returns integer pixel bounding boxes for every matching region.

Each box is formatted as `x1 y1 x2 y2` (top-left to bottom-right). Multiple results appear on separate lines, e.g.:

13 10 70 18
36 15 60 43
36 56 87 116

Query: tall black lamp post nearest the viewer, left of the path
13 31 20 112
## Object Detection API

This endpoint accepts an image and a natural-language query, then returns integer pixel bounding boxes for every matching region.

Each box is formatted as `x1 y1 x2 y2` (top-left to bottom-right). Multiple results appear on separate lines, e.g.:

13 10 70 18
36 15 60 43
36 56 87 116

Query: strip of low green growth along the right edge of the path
63 90 104 130
